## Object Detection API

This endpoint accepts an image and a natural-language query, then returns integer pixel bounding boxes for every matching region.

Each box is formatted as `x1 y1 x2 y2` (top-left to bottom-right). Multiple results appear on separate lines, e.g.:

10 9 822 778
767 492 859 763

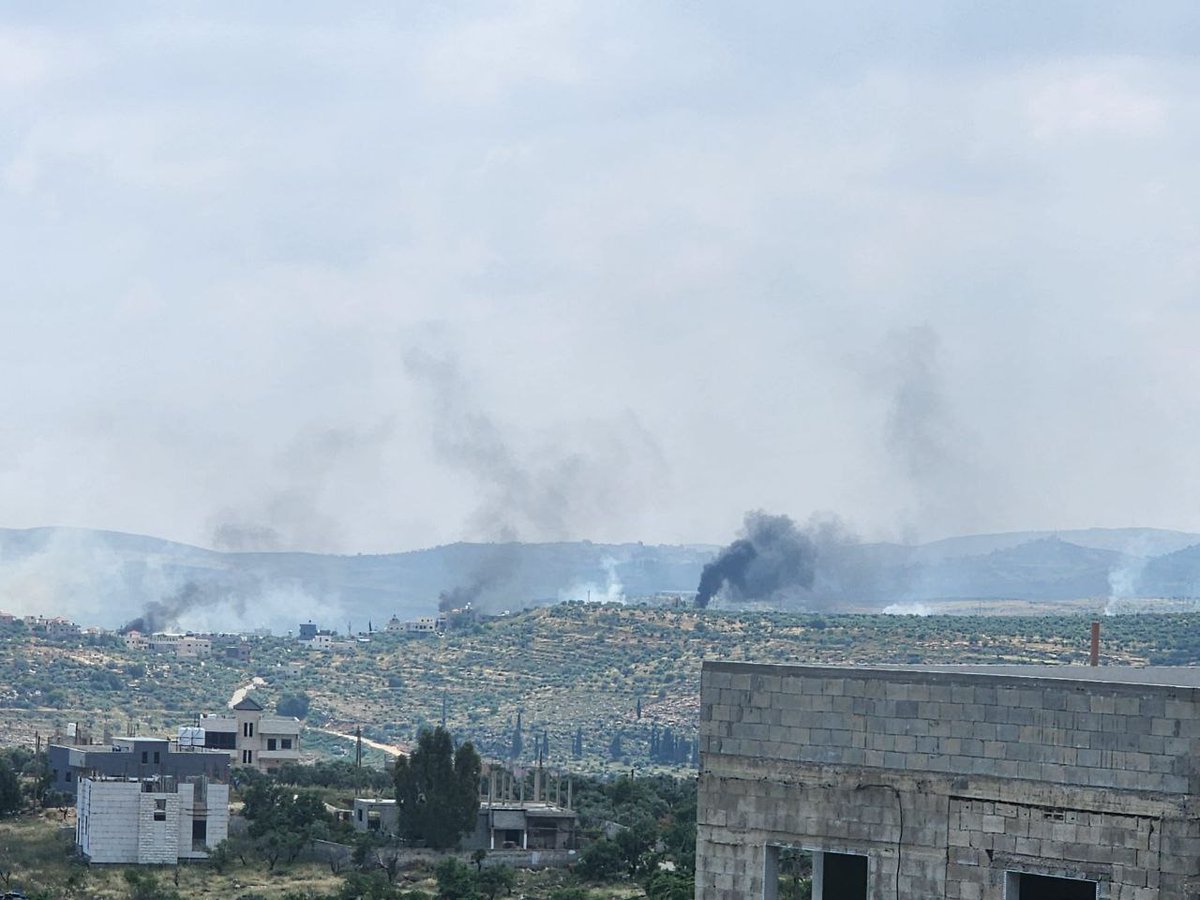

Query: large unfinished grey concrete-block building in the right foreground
696 662 1200 900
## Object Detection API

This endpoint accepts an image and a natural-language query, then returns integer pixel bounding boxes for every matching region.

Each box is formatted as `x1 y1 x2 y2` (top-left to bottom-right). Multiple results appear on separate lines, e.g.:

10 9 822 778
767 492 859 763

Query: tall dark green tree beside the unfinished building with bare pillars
396 726 481 850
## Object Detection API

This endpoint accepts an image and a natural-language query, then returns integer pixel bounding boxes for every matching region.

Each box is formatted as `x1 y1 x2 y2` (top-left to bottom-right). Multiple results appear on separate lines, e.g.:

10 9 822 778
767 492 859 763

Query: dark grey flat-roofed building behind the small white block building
47 732 229 794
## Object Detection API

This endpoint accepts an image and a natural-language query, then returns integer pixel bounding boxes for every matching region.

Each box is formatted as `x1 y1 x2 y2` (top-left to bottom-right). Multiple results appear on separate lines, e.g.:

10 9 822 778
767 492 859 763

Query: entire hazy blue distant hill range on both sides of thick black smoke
0 520 1200 634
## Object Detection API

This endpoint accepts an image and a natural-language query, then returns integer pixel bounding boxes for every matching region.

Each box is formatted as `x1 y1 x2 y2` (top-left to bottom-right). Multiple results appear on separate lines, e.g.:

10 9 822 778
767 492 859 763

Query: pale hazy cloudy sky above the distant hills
0 0 1200 552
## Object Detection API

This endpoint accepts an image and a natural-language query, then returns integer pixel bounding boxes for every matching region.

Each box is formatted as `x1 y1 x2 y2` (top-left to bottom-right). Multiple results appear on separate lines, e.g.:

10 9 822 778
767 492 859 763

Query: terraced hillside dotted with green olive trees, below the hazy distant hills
0 604 1200 772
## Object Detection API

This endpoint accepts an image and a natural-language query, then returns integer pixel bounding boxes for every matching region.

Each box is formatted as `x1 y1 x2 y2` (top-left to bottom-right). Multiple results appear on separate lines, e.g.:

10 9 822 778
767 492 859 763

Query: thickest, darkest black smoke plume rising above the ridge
696 510 817 608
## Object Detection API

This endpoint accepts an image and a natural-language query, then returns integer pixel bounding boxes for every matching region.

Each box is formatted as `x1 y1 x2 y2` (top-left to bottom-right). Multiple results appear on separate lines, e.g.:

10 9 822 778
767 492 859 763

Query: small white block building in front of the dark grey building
76 778 229 865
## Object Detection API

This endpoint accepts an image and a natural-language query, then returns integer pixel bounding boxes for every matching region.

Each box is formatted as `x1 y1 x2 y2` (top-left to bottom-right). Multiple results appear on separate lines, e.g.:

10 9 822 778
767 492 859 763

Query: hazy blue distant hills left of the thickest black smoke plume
0 528 715 632
